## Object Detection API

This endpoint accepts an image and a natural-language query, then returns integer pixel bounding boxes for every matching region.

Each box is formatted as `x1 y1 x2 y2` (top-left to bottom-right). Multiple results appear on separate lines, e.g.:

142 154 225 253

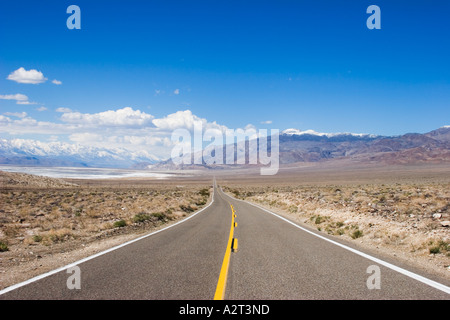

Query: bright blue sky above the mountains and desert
0 0 450 157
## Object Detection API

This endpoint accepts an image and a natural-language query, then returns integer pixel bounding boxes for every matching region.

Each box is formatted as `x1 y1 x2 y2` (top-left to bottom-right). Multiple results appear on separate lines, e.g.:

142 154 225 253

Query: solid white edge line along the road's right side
221 189 450 294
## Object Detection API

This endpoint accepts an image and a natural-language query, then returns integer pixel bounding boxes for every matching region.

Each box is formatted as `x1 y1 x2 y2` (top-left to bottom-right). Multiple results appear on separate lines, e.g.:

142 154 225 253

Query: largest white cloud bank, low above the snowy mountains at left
0 107 252 158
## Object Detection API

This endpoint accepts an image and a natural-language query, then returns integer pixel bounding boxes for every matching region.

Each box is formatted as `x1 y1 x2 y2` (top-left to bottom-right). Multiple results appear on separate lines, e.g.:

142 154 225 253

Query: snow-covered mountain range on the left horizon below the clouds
0 139 160 167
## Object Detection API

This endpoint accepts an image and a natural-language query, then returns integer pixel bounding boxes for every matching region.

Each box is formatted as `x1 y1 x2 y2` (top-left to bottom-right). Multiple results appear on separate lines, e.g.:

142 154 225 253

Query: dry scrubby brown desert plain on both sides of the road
0 161 450 289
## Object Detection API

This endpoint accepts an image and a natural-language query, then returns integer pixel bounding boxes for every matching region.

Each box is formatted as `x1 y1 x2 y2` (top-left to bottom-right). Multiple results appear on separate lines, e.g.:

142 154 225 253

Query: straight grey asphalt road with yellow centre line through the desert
0 182 450 300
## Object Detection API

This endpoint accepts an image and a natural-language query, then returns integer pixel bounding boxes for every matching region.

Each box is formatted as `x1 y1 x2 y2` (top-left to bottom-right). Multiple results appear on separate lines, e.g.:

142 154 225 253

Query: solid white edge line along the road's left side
0 184 215 295
